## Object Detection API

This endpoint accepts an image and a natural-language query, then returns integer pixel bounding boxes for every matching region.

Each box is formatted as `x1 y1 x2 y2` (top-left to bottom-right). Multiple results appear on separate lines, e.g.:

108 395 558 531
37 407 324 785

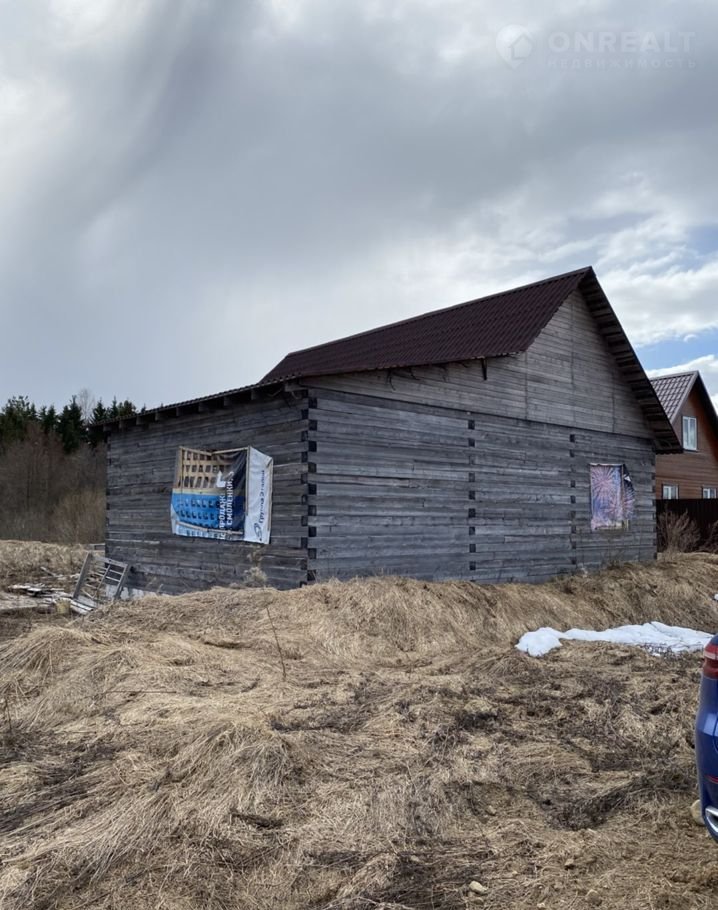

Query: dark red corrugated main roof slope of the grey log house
262 268 593 382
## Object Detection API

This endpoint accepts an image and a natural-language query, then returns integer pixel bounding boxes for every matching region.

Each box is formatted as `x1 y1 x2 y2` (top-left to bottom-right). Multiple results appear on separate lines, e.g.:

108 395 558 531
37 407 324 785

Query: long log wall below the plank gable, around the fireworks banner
308 389 655 581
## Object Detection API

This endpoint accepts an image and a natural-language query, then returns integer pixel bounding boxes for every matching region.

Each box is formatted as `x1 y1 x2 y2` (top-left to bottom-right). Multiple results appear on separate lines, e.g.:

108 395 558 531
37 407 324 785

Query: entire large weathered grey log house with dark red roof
105 268 680 592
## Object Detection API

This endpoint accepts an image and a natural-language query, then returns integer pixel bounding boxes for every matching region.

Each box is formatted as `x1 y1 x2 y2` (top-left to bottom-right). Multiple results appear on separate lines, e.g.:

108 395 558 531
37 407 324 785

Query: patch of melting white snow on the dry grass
516 622 713 657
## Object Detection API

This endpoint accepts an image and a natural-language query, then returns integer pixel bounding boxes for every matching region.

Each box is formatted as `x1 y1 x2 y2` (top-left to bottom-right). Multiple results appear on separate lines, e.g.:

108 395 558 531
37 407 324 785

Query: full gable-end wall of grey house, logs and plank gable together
308 295 655 581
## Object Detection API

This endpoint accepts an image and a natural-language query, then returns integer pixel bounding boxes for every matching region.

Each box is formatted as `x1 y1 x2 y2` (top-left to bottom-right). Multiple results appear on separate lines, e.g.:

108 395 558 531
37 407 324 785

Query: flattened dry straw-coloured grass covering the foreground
0 556 718 910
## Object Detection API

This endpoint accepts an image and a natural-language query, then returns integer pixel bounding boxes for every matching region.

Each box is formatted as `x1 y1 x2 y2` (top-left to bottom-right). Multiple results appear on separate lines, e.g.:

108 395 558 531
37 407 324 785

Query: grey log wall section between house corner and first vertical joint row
308 390 470 579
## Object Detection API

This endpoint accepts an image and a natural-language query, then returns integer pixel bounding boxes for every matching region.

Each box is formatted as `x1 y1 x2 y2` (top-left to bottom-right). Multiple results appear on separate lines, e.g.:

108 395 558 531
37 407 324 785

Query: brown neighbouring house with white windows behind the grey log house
653 372 718 499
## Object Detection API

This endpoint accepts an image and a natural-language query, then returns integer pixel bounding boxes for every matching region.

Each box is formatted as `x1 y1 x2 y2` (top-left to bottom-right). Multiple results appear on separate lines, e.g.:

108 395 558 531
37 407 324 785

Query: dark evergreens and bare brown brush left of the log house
0 389 138 543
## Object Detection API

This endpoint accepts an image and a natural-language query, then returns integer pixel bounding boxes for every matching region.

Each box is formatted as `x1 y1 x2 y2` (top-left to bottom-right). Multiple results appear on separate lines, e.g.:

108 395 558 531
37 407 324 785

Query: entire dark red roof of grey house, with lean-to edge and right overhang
103 267 683 453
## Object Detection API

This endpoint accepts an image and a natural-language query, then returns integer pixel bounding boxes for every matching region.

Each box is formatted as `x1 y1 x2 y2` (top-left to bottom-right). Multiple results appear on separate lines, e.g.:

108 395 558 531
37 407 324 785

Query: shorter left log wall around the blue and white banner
107 399 308 593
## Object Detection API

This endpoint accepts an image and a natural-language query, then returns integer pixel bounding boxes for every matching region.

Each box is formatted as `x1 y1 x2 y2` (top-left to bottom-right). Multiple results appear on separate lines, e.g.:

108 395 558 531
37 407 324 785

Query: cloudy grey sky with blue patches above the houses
0 0 718 405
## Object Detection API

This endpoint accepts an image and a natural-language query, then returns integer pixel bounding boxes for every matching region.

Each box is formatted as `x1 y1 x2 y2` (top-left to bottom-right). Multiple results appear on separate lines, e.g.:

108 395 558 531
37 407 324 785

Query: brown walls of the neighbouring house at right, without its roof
656 385 718 499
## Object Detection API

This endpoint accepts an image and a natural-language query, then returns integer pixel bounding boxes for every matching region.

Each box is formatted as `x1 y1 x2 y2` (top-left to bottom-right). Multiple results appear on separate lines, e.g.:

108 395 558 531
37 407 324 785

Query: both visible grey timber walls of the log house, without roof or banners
107 294 655 592
